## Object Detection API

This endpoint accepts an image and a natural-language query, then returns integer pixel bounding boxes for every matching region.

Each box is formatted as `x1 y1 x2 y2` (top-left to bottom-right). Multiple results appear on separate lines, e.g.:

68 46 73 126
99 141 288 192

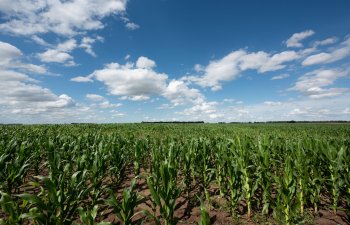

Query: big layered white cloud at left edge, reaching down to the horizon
0 42 82 123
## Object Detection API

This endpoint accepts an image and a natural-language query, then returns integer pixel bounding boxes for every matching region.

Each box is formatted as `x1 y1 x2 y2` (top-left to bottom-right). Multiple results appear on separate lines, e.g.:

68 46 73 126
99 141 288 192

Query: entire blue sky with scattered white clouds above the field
0 0 350 123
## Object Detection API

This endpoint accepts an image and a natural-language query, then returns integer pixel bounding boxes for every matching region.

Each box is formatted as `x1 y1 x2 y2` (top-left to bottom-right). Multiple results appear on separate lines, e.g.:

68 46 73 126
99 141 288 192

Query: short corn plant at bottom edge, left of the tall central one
107 179 142 225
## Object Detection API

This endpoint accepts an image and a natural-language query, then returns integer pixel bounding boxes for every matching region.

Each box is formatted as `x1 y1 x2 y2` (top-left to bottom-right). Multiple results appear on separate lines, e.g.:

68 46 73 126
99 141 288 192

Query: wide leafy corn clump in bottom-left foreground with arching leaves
19 170 88 225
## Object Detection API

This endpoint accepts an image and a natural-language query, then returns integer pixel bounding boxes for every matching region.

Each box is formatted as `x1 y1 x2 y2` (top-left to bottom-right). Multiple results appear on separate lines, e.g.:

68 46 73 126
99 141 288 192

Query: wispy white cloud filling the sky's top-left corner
0 0 127 35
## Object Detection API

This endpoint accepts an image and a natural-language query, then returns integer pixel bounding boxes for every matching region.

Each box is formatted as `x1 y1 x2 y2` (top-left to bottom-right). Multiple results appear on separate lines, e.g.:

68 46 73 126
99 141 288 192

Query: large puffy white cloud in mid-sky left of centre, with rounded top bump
71 56 205 106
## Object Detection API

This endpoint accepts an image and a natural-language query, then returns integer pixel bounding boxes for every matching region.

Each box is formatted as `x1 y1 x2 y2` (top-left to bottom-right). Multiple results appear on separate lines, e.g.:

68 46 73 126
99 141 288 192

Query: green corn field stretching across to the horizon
0 124 350 225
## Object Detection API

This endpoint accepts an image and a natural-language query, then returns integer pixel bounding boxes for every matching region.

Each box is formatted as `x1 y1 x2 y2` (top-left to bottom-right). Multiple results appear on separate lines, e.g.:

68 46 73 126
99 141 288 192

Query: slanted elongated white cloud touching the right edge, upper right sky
302 37 350 66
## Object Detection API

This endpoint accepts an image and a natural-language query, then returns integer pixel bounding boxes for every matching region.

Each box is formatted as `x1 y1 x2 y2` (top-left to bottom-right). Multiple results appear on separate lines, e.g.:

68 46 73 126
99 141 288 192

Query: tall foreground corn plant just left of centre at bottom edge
145 160 181 225
